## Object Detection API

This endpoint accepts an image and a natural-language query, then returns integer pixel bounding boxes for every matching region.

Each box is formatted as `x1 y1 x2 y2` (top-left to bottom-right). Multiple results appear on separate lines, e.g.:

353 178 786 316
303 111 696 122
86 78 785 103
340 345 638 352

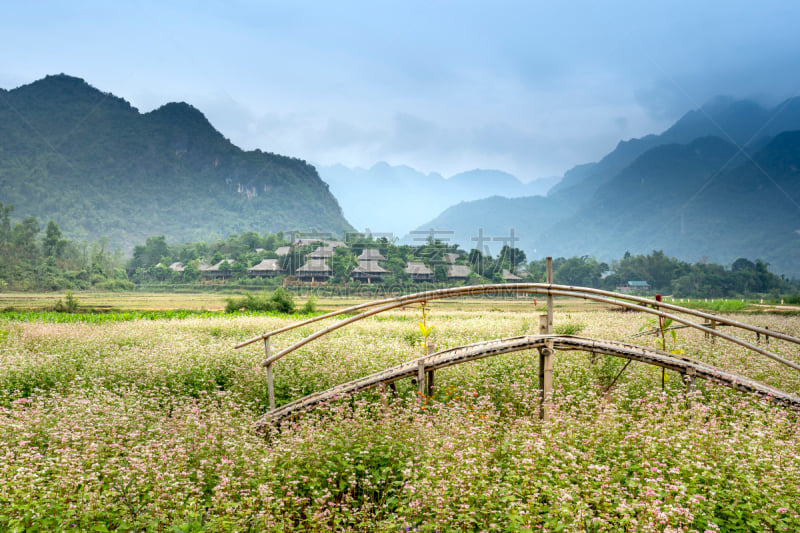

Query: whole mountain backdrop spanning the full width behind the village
0 74 800 277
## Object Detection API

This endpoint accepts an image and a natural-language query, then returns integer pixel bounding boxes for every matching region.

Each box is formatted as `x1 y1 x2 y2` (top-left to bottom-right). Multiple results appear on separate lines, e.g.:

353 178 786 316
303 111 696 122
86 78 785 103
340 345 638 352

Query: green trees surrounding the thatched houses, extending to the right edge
123 228 798 298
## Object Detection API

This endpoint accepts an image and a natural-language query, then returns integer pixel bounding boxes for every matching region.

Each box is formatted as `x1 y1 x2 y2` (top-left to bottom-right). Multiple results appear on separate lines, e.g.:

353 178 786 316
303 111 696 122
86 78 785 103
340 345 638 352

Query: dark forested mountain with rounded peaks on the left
0 74 353 250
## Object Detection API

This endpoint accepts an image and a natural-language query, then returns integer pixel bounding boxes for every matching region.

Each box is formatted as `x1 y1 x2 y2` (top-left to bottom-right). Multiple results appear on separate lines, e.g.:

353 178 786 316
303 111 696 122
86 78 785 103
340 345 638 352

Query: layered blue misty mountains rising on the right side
418 98 800 277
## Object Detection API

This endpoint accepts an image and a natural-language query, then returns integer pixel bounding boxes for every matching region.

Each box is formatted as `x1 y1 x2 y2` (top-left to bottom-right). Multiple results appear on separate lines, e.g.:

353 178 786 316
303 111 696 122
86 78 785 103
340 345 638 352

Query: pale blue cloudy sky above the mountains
0 0 800 181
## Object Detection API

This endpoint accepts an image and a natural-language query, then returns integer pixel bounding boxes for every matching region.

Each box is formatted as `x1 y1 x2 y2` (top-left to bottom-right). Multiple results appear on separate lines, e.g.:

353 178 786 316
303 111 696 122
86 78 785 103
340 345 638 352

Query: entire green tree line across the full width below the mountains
0 214 800 301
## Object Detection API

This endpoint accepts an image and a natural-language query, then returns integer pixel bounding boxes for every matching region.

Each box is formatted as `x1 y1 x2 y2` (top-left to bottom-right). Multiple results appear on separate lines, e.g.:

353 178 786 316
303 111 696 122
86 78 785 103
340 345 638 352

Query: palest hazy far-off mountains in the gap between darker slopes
318 162 559 237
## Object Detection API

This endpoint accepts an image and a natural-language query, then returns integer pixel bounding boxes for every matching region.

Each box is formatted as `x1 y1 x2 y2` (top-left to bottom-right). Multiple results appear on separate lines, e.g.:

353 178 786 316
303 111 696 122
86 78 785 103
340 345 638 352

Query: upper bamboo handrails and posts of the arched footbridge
234 280 800 410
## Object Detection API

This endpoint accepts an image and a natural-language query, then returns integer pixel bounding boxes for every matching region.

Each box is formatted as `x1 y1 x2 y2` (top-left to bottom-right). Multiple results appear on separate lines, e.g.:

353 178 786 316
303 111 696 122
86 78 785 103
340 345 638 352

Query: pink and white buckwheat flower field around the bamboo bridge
0 304 800 533
